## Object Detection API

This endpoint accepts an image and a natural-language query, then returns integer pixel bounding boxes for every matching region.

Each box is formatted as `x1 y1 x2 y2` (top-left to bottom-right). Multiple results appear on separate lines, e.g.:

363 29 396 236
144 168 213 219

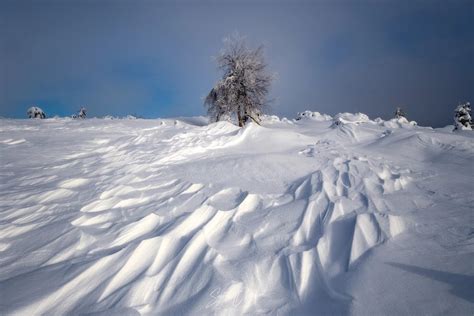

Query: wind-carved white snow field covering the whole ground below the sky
0 113 474 315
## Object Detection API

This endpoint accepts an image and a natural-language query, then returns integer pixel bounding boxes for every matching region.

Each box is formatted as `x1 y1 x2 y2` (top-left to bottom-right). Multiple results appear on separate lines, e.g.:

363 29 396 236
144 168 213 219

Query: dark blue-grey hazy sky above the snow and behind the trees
0 0 474 126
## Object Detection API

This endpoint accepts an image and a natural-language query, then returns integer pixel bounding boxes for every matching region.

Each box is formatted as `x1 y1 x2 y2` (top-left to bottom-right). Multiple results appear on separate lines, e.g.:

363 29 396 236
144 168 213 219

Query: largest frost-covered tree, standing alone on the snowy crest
204 35 273 126
